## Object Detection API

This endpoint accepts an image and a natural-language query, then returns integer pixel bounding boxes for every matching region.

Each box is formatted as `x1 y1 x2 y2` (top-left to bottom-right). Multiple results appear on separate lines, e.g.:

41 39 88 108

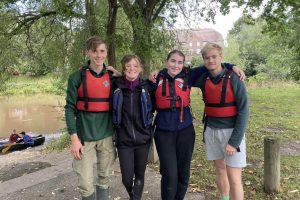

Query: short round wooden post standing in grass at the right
264 137 280 194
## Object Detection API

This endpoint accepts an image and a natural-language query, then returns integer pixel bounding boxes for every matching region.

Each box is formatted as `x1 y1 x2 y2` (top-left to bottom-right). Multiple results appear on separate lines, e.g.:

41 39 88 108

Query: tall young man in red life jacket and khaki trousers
65 37 116 200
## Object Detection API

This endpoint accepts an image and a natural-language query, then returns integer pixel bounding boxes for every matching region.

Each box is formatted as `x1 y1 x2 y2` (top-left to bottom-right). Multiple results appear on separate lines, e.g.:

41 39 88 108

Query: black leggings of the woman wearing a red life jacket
154 125 195 200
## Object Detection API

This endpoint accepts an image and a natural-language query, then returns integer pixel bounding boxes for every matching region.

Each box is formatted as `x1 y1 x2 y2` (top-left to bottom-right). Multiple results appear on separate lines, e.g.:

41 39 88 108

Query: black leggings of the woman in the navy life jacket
118 143 150 193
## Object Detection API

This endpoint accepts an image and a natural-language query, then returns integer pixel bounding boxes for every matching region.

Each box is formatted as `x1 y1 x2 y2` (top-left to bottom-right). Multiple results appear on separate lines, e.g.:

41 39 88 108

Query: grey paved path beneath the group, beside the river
0 149 205 200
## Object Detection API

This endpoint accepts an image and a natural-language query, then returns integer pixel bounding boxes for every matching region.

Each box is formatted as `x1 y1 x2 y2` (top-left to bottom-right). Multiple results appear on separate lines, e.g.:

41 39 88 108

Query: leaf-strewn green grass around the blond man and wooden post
190 83 300 200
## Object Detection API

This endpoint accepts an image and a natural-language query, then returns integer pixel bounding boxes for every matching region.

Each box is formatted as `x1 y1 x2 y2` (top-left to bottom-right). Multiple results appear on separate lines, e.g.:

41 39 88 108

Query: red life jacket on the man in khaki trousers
76 67 111 112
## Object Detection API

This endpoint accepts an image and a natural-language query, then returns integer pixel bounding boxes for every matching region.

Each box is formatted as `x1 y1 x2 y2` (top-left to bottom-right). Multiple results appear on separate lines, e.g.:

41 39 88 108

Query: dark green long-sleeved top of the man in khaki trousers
65 67 114 141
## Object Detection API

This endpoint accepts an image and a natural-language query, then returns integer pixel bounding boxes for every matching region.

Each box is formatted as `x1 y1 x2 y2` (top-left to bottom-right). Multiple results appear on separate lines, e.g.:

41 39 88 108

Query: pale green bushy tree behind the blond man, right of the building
225 17 297 78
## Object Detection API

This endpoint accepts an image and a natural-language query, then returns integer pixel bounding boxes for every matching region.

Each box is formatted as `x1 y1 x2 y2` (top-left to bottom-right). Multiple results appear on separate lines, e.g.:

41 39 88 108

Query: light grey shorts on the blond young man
204 126 246 168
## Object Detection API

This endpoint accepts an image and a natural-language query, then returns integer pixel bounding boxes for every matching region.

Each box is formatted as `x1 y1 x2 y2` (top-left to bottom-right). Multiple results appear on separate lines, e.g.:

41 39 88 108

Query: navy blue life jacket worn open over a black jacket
112 86 153 128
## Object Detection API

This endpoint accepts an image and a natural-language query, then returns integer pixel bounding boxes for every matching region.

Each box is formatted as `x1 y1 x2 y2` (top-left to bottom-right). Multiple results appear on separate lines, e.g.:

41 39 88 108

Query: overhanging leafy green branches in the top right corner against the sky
227 0 300 80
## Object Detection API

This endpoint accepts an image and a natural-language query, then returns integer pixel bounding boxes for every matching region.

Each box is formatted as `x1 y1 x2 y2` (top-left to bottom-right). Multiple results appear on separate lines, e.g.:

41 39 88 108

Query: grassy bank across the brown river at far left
0 76 65 96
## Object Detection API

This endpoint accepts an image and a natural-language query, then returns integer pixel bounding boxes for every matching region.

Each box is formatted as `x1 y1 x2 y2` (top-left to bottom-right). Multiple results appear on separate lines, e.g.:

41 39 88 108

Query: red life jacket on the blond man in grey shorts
203 71 237 117
